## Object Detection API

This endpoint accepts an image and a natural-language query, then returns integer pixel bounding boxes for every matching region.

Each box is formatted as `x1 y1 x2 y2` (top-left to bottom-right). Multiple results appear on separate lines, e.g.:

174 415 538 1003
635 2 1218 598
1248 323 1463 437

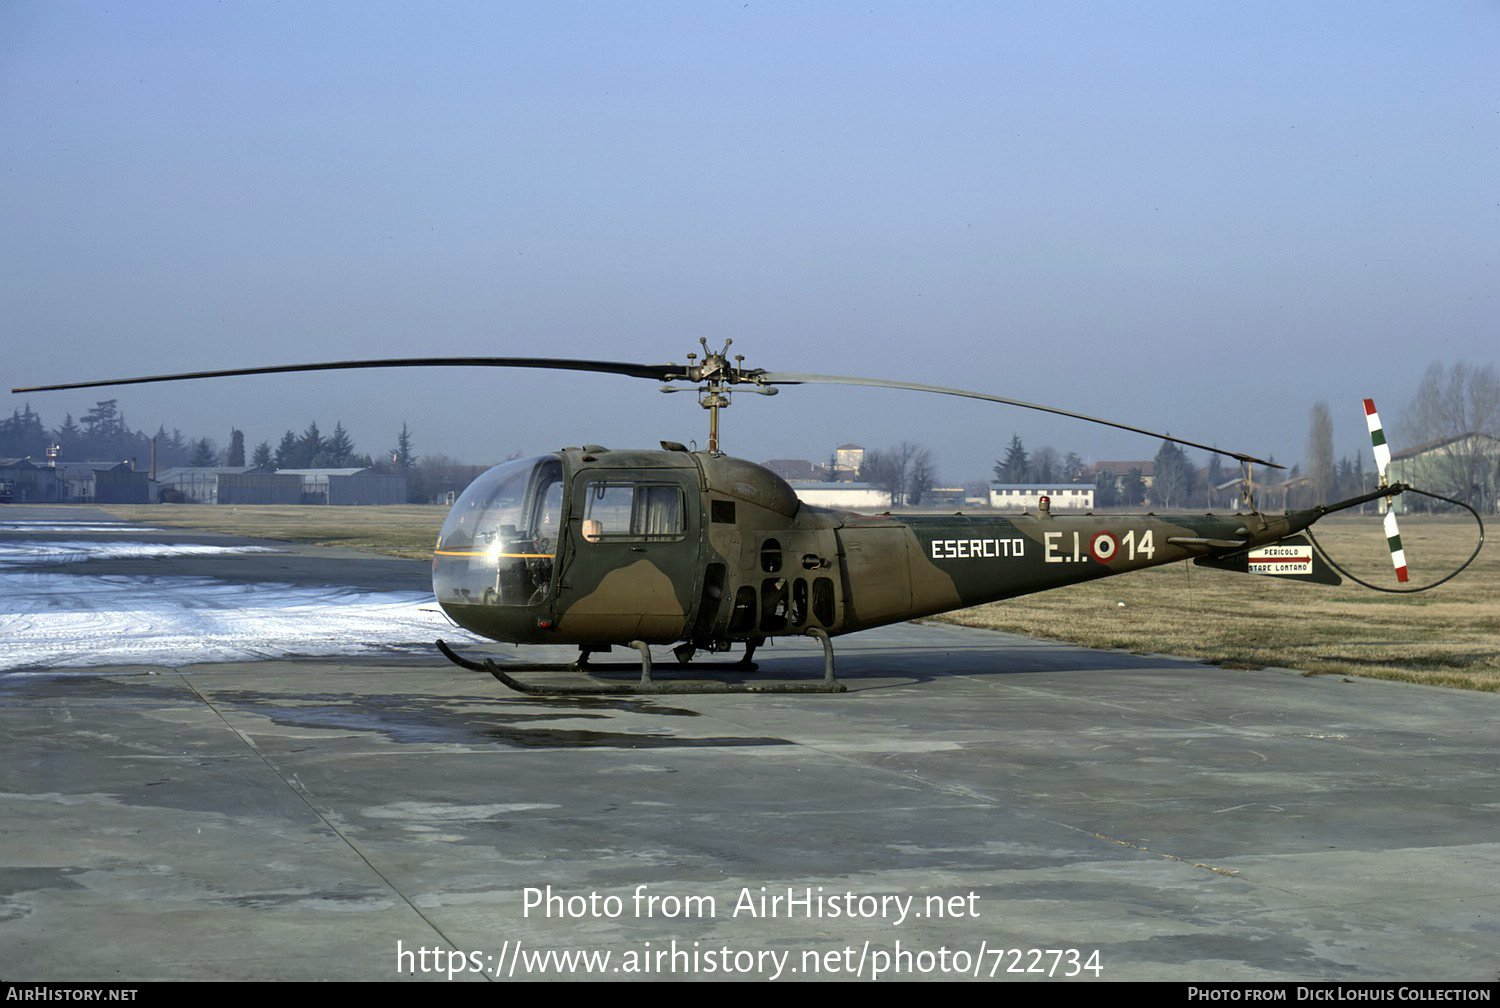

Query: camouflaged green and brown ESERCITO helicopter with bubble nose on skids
12 339 1484 696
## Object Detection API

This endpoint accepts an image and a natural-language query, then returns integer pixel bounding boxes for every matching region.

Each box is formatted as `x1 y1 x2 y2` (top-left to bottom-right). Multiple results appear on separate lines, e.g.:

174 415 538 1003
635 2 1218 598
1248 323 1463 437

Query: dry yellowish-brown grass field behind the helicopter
104 504 1500 692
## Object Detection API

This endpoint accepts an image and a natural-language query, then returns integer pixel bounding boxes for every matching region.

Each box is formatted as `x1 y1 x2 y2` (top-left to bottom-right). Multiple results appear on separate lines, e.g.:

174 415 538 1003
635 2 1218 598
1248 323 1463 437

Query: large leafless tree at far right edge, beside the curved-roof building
1400 363 1500 512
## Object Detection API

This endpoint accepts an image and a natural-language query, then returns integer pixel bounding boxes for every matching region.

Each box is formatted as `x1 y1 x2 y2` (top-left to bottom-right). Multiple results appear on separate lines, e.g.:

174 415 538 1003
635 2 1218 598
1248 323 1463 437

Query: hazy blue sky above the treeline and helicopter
0 0 1500 480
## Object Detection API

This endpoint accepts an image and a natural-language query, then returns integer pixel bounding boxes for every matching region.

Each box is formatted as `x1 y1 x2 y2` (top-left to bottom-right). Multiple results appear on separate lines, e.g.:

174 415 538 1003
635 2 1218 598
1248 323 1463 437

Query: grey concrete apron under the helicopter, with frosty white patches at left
0 509 1500 981
